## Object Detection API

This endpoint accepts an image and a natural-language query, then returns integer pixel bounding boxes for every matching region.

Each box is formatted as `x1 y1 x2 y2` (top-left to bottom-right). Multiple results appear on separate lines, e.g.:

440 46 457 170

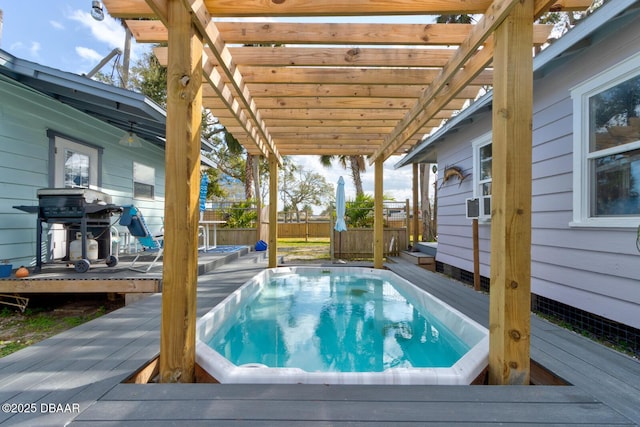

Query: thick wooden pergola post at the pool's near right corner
489 0 534 385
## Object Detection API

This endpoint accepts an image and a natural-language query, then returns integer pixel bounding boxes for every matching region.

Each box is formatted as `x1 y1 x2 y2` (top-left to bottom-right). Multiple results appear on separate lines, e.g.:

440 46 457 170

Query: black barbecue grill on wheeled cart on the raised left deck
14 188 122 273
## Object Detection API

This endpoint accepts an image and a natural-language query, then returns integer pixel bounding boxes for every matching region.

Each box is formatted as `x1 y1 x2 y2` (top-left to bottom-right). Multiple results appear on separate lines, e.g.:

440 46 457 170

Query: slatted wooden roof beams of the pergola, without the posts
103 0 591 162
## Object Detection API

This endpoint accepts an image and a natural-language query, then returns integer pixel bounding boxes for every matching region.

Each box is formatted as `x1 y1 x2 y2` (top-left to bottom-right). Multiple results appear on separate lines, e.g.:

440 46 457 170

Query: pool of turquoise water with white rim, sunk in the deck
196 267 488 384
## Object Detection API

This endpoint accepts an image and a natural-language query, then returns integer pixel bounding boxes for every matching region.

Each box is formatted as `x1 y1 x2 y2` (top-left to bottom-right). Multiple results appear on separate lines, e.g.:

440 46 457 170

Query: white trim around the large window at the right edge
569 53 640 228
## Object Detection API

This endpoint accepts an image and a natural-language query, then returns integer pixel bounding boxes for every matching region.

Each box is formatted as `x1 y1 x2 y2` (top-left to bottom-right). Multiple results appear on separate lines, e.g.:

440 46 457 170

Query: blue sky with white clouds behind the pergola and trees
0 0 424 211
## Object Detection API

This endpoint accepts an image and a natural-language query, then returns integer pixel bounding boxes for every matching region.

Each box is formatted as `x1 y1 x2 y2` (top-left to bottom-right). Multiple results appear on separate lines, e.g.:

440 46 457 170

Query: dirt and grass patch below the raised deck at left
0 294 124 357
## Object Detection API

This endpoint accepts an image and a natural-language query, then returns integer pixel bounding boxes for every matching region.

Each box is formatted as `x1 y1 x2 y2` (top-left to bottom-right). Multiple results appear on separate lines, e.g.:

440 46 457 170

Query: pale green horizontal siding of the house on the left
0 76 164 267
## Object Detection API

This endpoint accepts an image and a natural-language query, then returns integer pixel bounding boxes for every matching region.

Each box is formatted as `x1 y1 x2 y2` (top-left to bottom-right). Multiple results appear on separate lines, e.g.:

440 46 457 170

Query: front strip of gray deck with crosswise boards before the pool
73 384 632 425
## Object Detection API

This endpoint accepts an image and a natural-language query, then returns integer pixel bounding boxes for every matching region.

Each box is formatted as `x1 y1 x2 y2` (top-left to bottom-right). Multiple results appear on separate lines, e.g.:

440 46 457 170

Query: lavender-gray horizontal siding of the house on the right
437 15 640 328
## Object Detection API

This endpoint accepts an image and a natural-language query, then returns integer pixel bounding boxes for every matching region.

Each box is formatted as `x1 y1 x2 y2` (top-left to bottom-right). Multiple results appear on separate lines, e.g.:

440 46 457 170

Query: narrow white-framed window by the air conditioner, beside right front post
472 133 493 220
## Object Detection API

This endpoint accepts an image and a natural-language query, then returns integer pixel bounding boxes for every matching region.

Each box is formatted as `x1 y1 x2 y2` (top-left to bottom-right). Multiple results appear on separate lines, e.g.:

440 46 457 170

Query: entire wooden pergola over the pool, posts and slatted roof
104 0 591 384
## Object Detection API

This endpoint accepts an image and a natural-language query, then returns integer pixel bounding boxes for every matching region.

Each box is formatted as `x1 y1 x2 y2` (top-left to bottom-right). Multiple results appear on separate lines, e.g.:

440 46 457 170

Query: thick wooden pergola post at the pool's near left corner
160 0 202 383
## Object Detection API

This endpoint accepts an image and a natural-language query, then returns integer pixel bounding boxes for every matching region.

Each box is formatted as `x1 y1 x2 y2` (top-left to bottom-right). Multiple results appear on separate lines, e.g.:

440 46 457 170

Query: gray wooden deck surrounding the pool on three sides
0 253 640 426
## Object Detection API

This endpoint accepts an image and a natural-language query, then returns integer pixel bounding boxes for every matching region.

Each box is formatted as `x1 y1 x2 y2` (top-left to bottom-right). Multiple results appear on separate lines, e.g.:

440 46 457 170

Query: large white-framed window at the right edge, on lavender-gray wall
571 51 640 227
